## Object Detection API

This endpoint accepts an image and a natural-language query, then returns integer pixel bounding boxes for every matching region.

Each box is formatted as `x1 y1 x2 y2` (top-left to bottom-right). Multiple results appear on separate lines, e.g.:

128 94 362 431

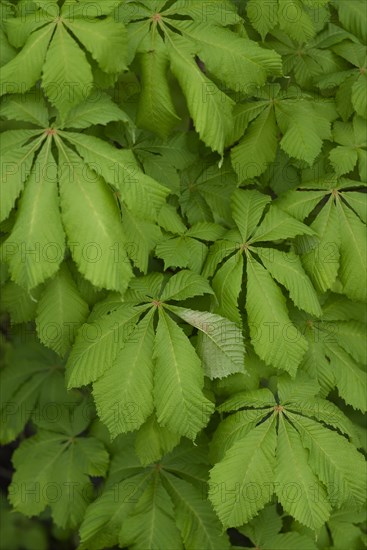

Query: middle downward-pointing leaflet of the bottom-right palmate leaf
275 414 331 531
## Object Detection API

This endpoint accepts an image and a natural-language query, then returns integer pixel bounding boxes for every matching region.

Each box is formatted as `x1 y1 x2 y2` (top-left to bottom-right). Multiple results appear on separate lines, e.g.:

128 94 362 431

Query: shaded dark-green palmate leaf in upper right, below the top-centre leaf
229 88 337 182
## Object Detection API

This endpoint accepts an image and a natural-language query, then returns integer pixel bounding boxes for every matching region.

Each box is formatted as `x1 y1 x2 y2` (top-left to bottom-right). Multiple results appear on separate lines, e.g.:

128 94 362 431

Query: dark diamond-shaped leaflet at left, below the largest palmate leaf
36 264 89 357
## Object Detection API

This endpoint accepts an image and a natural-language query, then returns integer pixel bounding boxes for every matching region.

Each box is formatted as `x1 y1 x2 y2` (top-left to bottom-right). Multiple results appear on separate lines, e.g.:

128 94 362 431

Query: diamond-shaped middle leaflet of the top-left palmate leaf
42 23 93 118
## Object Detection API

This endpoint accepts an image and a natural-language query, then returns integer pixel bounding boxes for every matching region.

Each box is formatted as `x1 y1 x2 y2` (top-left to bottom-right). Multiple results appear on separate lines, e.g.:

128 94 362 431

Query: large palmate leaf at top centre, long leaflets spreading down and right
120 2 281 155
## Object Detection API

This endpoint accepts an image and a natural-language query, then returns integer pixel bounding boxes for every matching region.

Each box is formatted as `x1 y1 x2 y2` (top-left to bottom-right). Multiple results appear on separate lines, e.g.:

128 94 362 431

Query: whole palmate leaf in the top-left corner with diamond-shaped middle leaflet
1 3 127 119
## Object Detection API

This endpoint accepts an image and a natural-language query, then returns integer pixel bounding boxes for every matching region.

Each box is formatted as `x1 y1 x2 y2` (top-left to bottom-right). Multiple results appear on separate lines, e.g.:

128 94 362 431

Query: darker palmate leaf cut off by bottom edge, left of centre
80 436 229 550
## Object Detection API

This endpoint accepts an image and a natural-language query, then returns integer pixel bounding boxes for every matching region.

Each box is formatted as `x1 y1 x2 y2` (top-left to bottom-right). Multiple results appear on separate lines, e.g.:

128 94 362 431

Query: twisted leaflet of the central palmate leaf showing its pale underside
166 305 245 378
